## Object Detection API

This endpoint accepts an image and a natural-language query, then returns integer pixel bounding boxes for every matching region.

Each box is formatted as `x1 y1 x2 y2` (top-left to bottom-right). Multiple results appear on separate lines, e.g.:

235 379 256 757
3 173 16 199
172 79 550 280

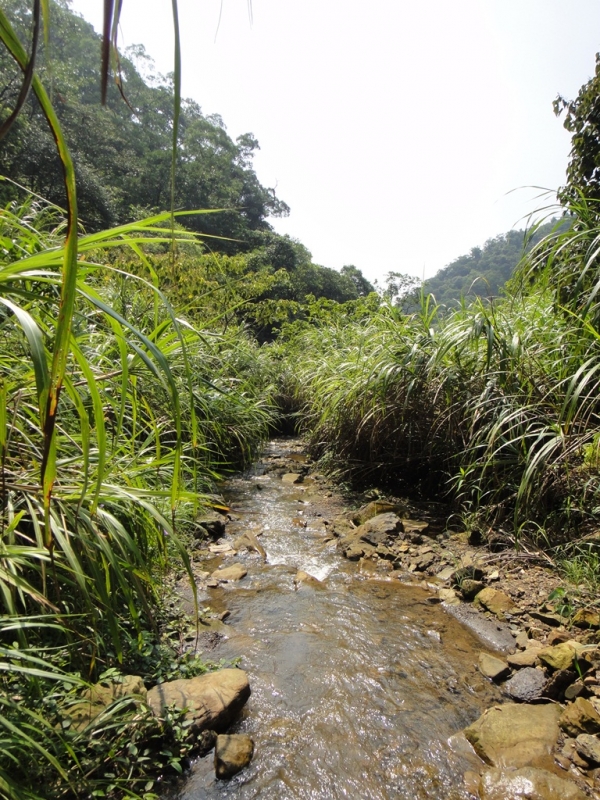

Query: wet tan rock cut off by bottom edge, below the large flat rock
479 767 586 800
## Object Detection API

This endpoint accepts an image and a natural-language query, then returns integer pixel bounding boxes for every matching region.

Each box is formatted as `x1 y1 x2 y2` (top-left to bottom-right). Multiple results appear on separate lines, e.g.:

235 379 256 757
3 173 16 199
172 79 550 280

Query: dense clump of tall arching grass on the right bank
289 204 600 539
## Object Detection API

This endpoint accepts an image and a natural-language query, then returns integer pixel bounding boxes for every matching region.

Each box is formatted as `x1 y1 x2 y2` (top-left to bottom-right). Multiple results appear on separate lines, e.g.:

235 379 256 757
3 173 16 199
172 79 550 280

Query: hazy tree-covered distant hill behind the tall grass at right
425 220 557 305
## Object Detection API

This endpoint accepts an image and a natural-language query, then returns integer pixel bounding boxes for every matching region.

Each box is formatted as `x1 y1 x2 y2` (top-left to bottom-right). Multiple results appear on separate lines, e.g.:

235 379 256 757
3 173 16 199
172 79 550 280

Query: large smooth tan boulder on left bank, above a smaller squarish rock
147 669 250 731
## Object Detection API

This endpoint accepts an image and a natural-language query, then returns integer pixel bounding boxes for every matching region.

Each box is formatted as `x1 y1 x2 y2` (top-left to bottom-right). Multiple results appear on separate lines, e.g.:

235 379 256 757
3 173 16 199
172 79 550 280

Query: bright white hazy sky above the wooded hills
72 0 600 282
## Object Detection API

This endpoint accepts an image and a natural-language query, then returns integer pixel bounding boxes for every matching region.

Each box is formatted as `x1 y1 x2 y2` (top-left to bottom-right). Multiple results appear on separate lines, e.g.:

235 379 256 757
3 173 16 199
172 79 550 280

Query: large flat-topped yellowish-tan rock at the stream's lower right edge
464 703 561 768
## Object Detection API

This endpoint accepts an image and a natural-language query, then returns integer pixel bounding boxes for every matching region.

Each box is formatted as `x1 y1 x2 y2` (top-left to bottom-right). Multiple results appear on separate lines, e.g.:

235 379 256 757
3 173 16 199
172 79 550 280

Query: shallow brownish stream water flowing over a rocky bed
172 440 497 800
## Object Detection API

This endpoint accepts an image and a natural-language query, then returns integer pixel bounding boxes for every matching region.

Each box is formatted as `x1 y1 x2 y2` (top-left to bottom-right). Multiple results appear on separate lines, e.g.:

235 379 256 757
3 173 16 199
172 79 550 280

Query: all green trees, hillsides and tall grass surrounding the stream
0 0 600 800
